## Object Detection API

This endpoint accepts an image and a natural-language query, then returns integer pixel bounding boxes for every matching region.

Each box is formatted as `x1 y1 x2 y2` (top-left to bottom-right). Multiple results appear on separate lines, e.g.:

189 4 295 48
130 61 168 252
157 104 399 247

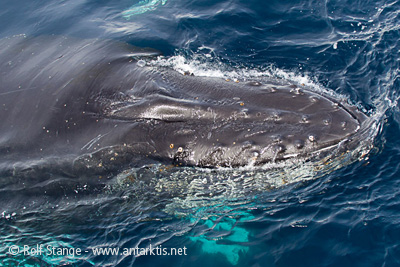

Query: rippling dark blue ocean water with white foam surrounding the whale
0 0 400 266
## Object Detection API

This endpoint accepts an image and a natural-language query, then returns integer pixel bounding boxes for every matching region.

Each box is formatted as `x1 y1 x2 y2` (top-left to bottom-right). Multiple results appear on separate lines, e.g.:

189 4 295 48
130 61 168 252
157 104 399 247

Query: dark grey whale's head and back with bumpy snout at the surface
0 36 367 176
